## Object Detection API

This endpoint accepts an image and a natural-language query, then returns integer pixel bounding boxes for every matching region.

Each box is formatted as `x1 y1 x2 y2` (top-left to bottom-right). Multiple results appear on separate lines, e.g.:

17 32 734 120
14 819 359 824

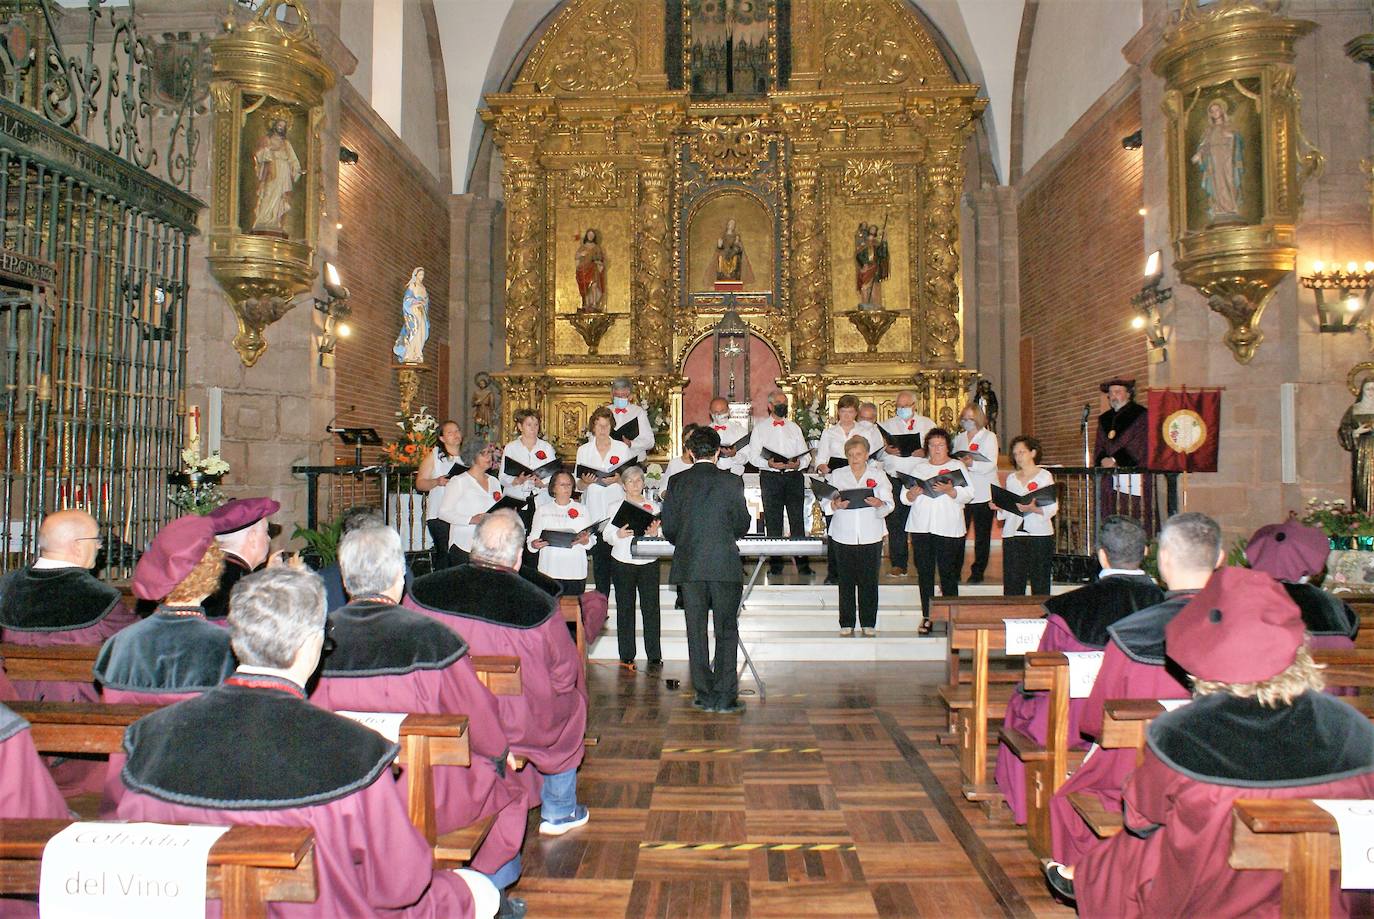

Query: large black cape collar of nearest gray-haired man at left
122 674 400 810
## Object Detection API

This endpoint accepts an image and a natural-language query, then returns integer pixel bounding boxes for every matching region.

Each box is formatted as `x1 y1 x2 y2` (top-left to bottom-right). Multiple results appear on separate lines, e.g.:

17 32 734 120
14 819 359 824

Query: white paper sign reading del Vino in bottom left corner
38 823 228 919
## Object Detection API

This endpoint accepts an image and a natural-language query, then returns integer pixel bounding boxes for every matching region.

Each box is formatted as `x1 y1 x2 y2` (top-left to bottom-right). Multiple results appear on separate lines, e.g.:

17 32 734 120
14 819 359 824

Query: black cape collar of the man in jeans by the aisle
411 565 558 629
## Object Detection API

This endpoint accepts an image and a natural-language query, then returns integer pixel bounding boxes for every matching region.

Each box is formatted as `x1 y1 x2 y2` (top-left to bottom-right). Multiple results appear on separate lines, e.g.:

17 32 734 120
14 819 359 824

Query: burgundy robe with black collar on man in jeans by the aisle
407 565 587 775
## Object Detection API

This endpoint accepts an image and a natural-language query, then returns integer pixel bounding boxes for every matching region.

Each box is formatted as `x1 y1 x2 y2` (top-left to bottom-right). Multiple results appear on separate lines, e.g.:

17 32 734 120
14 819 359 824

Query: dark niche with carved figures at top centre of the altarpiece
687 0 772 96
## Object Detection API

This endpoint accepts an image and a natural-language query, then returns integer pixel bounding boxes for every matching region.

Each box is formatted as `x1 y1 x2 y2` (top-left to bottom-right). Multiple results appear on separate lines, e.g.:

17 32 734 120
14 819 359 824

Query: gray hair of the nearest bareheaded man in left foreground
229 566 326 670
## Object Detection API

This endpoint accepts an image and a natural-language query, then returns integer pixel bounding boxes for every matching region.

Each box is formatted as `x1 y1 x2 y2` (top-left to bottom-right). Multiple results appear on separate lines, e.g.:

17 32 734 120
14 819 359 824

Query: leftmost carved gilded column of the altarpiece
503 157 544 371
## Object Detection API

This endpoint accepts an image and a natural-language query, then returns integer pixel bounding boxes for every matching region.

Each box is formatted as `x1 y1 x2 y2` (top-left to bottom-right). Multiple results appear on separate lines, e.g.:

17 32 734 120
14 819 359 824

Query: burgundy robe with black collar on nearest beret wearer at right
1074 692 1374 919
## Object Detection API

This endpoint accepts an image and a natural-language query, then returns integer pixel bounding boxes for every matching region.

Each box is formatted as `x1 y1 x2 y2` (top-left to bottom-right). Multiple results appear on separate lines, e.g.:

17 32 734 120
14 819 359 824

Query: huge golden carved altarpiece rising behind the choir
482 0 985 451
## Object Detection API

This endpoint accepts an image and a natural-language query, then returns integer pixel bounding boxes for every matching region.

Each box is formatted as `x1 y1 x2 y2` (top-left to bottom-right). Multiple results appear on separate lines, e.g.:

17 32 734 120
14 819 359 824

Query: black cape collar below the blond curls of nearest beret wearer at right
1147 691 1374 788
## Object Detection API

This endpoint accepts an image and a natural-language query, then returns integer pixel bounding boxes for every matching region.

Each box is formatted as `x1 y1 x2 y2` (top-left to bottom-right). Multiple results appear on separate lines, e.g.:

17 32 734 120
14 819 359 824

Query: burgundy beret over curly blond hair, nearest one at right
1164 567 1304 683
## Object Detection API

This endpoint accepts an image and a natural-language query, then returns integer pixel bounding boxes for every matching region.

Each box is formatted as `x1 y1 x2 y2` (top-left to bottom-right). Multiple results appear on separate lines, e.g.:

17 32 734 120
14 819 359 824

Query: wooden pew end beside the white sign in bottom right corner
1227 798 1341 919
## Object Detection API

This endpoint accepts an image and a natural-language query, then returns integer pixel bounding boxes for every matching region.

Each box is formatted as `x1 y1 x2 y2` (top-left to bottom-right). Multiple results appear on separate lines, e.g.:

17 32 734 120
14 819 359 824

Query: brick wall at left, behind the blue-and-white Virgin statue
334 87 451 459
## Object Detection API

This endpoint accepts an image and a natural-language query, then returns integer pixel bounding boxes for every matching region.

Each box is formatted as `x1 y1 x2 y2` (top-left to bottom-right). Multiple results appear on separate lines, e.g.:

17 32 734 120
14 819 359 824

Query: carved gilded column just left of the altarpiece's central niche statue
631 154 673 375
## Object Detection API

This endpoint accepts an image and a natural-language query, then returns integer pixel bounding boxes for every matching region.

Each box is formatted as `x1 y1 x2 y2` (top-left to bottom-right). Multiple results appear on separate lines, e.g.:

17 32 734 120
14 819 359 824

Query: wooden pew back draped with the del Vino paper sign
0 820 319 919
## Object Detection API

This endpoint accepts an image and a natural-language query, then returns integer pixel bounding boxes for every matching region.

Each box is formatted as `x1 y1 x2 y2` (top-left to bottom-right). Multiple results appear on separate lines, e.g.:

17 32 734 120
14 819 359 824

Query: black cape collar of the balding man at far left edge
0 567 120 632
